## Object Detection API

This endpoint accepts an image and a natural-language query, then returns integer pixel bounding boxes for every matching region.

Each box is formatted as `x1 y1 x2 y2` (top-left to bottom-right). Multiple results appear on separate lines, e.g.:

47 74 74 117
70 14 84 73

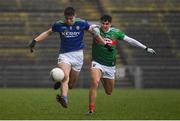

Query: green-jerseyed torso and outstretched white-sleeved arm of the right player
92 24 155 66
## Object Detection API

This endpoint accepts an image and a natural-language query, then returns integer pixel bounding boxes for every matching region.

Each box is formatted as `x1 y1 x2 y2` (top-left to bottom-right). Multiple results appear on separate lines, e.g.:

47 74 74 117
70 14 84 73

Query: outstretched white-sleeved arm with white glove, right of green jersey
123 35 156 54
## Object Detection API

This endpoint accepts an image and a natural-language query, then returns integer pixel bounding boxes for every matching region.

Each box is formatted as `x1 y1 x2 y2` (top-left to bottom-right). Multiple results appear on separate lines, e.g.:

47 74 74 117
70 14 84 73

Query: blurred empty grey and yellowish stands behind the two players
0 0 180 88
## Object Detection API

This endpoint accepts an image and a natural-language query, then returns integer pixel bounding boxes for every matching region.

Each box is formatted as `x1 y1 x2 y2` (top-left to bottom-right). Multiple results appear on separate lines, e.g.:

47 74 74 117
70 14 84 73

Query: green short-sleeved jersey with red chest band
92 27 125 66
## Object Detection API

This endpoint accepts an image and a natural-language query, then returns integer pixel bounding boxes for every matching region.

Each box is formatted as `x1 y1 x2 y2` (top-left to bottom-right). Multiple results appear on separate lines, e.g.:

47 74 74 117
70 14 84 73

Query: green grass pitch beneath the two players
0 89 180 120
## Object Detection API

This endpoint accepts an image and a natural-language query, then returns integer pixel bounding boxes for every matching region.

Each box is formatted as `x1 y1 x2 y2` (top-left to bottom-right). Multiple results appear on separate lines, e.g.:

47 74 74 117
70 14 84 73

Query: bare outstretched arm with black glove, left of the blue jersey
29 28 53 53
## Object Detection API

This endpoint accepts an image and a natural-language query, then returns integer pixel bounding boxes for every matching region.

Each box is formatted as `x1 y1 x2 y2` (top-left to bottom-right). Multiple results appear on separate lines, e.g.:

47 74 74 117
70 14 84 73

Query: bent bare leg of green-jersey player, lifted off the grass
102 78 115 95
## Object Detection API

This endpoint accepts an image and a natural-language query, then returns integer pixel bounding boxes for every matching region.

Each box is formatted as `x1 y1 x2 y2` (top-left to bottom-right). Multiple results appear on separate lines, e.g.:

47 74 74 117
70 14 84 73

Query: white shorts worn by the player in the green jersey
91 61 116 79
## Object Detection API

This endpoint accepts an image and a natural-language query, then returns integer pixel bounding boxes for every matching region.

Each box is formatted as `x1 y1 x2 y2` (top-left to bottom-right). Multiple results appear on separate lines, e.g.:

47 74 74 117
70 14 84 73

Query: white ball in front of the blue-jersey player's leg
50 67 64 82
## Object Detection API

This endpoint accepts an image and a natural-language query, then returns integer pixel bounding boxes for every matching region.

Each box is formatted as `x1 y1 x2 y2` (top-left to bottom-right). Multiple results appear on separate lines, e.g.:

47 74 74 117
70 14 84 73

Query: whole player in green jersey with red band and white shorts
89 15 155 113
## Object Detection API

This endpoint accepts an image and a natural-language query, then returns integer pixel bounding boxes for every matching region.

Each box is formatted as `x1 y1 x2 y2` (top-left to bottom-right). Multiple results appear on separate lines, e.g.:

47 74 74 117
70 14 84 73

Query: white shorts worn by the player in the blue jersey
58 50 84 71
